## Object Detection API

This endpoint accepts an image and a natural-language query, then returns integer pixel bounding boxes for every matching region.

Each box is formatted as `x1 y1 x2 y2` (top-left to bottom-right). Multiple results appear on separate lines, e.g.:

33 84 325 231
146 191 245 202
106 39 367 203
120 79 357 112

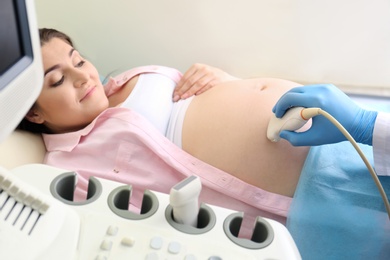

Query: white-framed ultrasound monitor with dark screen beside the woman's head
0 0 43 142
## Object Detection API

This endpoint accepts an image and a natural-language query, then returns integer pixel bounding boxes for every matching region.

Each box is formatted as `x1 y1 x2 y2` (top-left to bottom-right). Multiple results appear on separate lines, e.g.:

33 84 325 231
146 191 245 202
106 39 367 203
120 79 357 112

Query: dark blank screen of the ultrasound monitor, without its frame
0 0 24 76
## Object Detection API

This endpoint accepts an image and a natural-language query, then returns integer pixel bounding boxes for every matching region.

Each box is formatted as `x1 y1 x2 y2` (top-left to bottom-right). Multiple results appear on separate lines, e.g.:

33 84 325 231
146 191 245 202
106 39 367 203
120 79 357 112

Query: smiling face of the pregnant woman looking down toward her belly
27 38 108 133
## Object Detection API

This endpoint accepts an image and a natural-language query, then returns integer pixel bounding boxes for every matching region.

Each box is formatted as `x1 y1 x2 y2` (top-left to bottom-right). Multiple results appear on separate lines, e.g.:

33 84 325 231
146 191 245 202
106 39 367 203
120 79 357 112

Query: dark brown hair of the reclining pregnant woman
17 28 73 133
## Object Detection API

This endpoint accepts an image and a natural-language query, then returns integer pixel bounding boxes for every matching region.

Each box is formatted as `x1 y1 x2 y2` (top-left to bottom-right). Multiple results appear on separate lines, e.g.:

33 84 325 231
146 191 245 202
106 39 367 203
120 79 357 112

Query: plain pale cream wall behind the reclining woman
35 0 390 95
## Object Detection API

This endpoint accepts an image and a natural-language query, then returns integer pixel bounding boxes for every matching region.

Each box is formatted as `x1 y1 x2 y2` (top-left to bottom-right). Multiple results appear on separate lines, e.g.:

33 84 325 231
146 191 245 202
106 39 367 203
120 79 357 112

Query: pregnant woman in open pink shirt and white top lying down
20 29 309 232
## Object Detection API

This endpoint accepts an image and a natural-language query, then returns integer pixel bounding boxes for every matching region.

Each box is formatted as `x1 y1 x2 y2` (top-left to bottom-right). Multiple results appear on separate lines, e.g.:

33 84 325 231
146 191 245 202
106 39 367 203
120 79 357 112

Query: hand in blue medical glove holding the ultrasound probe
272 84 377 146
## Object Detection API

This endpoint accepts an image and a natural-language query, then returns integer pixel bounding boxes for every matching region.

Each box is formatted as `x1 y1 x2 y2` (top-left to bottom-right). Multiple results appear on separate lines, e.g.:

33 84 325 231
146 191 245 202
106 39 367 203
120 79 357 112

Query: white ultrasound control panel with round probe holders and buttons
0 164 301 260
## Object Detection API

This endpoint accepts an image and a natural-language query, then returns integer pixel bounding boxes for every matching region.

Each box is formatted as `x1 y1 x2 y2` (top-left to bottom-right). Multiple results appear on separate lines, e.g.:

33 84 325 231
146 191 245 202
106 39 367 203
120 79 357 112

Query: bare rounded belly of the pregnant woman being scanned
182 79 309 196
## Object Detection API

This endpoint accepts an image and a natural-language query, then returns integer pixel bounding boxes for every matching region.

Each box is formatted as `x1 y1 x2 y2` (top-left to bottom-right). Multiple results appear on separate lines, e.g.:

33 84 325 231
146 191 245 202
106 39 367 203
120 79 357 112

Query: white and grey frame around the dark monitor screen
0 0 43 142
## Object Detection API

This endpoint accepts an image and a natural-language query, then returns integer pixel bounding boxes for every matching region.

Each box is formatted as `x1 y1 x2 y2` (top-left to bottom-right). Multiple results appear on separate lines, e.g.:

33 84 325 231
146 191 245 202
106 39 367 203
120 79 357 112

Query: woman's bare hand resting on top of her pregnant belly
173 63 238 102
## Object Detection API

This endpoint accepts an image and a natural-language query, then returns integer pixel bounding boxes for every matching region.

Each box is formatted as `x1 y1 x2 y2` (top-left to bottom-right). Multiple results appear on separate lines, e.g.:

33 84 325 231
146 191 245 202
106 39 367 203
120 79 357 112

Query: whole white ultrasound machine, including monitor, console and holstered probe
0 0 301 260
